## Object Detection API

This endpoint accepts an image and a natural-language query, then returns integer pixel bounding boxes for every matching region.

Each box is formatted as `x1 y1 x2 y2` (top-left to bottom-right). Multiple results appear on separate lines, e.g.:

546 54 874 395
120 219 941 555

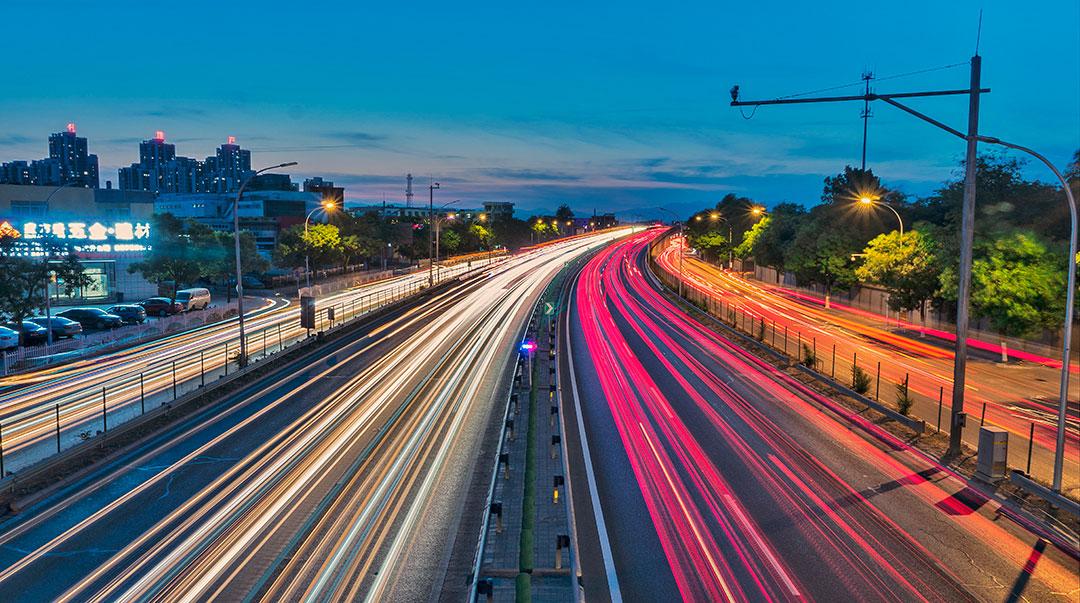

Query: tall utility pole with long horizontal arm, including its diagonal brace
731 53 989 456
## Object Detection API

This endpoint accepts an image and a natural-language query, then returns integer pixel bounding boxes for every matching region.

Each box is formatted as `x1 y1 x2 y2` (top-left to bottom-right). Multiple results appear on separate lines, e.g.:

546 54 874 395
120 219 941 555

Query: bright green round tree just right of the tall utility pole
941 232 1066 362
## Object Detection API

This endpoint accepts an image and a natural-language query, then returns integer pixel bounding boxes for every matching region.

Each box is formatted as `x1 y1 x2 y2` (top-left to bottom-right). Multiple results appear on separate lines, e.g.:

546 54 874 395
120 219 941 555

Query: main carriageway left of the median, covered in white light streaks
0 229 629 601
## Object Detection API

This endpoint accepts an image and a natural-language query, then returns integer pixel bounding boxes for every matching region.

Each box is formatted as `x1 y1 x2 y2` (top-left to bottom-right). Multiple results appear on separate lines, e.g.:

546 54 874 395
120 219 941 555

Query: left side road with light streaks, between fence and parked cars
0 265 481 471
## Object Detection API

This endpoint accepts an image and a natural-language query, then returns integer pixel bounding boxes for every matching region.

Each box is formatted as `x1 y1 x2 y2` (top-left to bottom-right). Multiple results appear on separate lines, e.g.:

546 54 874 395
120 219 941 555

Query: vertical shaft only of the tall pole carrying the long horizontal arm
947 54 983 455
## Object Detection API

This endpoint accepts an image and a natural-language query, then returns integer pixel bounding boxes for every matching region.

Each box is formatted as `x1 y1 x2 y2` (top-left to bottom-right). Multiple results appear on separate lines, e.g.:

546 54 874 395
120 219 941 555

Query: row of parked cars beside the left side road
0 289 210 350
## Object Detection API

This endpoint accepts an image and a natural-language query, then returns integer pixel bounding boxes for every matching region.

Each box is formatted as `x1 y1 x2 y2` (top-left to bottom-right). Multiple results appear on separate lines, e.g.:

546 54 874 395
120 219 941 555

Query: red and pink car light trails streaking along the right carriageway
573 231 1075 601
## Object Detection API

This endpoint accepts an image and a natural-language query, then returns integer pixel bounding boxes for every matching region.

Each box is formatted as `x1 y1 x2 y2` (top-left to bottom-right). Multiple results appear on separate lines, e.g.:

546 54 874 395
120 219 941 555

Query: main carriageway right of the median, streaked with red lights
559 230 1080 601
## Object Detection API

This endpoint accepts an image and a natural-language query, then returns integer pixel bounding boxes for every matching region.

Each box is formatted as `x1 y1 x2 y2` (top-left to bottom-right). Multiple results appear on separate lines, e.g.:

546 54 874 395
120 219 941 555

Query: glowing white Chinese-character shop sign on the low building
0 220 150 253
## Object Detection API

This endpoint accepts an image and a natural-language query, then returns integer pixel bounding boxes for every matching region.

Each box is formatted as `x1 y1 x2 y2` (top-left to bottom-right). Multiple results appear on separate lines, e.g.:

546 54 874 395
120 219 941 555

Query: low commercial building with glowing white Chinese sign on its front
0 185 157 305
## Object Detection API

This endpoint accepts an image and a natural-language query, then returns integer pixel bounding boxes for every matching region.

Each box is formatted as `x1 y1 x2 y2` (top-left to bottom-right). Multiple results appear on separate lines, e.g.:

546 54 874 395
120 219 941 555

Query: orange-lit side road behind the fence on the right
657 240 1080 499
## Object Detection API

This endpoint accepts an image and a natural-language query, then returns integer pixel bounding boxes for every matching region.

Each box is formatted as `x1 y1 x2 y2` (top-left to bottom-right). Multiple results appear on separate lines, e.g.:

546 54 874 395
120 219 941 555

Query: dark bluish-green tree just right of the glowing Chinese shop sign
127 213 212 300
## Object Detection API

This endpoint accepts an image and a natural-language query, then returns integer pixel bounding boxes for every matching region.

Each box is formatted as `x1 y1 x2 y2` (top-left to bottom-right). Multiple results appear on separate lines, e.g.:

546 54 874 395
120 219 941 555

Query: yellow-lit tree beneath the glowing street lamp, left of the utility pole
855 230 941 325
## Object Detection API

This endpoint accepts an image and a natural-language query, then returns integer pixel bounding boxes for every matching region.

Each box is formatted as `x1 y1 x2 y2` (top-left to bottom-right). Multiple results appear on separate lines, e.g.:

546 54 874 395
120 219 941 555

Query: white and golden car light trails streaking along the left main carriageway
0 229 630 601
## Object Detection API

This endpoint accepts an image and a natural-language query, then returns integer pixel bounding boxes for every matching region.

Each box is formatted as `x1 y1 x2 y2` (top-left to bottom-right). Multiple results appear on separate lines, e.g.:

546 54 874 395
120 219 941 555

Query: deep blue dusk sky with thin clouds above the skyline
0 0 1080 217
